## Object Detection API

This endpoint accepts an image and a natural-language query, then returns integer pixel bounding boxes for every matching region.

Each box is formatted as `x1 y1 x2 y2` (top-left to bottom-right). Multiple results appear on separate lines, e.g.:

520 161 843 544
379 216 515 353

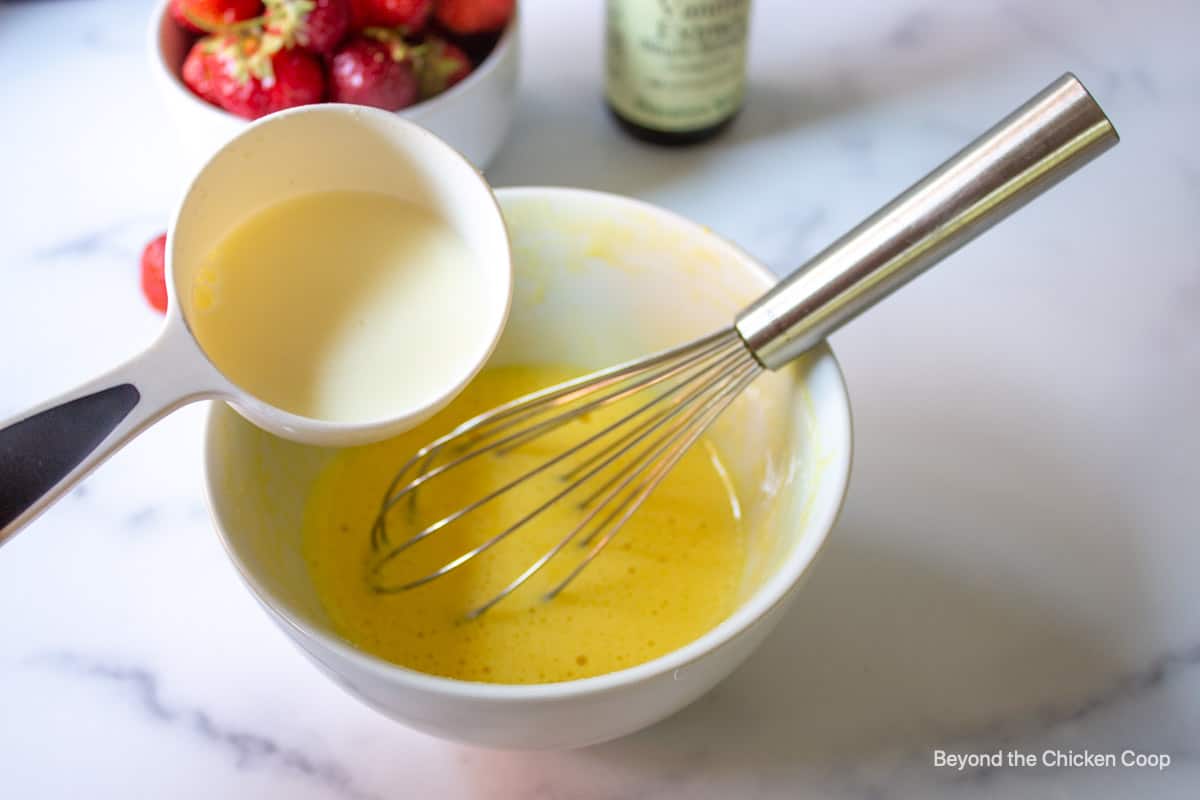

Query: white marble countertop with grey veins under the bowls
0 0 1200 800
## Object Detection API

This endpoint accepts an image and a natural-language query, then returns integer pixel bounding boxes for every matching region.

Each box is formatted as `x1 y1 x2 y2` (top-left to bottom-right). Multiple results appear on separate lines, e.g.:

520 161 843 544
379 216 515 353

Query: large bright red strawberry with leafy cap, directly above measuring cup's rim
182 35 325 120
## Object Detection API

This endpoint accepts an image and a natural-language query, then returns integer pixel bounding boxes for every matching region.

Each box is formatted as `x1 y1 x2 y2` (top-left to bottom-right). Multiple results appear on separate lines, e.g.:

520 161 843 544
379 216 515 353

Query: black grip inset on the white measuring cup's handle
0 384 142 529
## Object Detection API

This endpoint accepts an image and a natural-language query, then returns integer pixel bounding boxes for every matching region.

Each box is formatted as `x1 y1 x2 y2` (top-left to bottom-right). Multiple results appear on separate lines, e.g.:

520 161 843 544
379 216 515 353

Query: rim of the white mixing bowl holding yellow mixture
203 186 853 704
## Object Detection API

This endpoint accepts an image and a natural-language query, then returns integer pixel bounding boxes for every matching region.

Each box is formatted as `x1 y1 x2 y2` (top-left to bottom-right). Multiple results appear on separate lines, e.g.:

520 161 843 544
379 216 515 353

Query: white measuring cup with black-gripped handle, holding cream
0 104 512 545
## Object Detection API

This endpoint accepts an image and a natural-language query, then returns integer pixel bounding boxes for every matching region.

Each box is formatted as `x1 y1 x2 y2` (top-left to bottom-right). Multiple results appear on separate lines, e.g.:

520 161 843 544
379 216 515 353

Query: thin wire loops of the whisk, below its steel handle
368 329 762 609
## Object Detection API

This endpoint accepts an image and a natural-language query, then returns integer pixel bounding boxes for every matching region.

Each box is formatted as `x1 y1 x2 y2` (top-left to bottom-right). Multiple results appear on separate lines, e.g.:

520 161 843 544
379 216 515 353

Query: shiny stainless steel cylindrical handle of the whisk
736 73 1118 369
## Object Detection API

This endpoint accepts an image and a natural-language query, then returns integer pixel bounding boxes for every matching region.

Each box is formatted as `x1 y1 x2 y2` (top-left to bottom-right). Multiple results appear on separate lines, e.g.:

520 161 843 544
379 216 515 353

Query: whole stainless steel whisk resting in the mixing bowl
368 73 1118 618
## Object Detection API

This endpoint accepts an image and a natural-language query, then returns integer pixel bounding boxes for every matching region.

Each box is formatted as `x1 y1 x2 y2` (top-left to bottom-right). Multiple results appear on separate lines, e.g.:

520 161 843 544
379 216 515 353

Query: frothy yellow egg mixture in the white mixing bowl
304 366 745 684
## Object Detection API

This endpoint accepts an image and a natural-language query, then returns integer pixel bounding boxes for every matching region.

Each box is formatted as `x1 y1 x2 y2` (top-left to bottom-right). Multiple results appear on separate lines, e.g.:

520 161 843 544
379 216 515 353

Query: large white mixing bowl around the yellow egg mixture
206 188 851 748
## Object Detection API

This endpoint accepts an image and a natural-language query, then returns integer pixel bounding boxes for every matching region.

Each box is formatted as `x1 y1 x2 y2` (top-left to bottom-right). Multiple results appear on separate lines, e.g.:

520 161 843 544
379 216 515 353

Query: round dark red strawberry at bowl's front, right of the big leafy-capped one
329 29 420 112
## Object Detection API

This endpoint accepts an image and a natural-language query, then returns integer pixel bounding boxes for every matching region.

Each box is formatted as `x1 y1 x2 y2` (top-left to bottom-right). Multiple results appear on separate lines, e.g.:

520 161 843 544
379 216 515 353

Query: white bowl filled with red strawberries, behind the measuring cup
149 0 520 169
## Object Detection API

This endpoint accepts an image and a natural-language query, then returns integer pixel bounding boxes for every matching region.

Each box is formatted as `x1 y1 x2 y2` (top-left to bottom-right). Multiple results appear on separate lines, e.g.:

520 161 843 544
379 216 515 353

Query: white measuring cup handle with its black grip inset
0 325 218 545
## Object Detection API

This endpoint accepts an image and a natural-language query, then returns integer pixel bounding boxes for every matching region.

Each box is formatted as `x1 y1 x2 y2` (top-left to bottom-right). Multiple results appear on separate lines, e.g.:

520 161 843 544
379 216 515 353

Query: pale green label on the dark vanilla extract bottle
605 0 750 131
